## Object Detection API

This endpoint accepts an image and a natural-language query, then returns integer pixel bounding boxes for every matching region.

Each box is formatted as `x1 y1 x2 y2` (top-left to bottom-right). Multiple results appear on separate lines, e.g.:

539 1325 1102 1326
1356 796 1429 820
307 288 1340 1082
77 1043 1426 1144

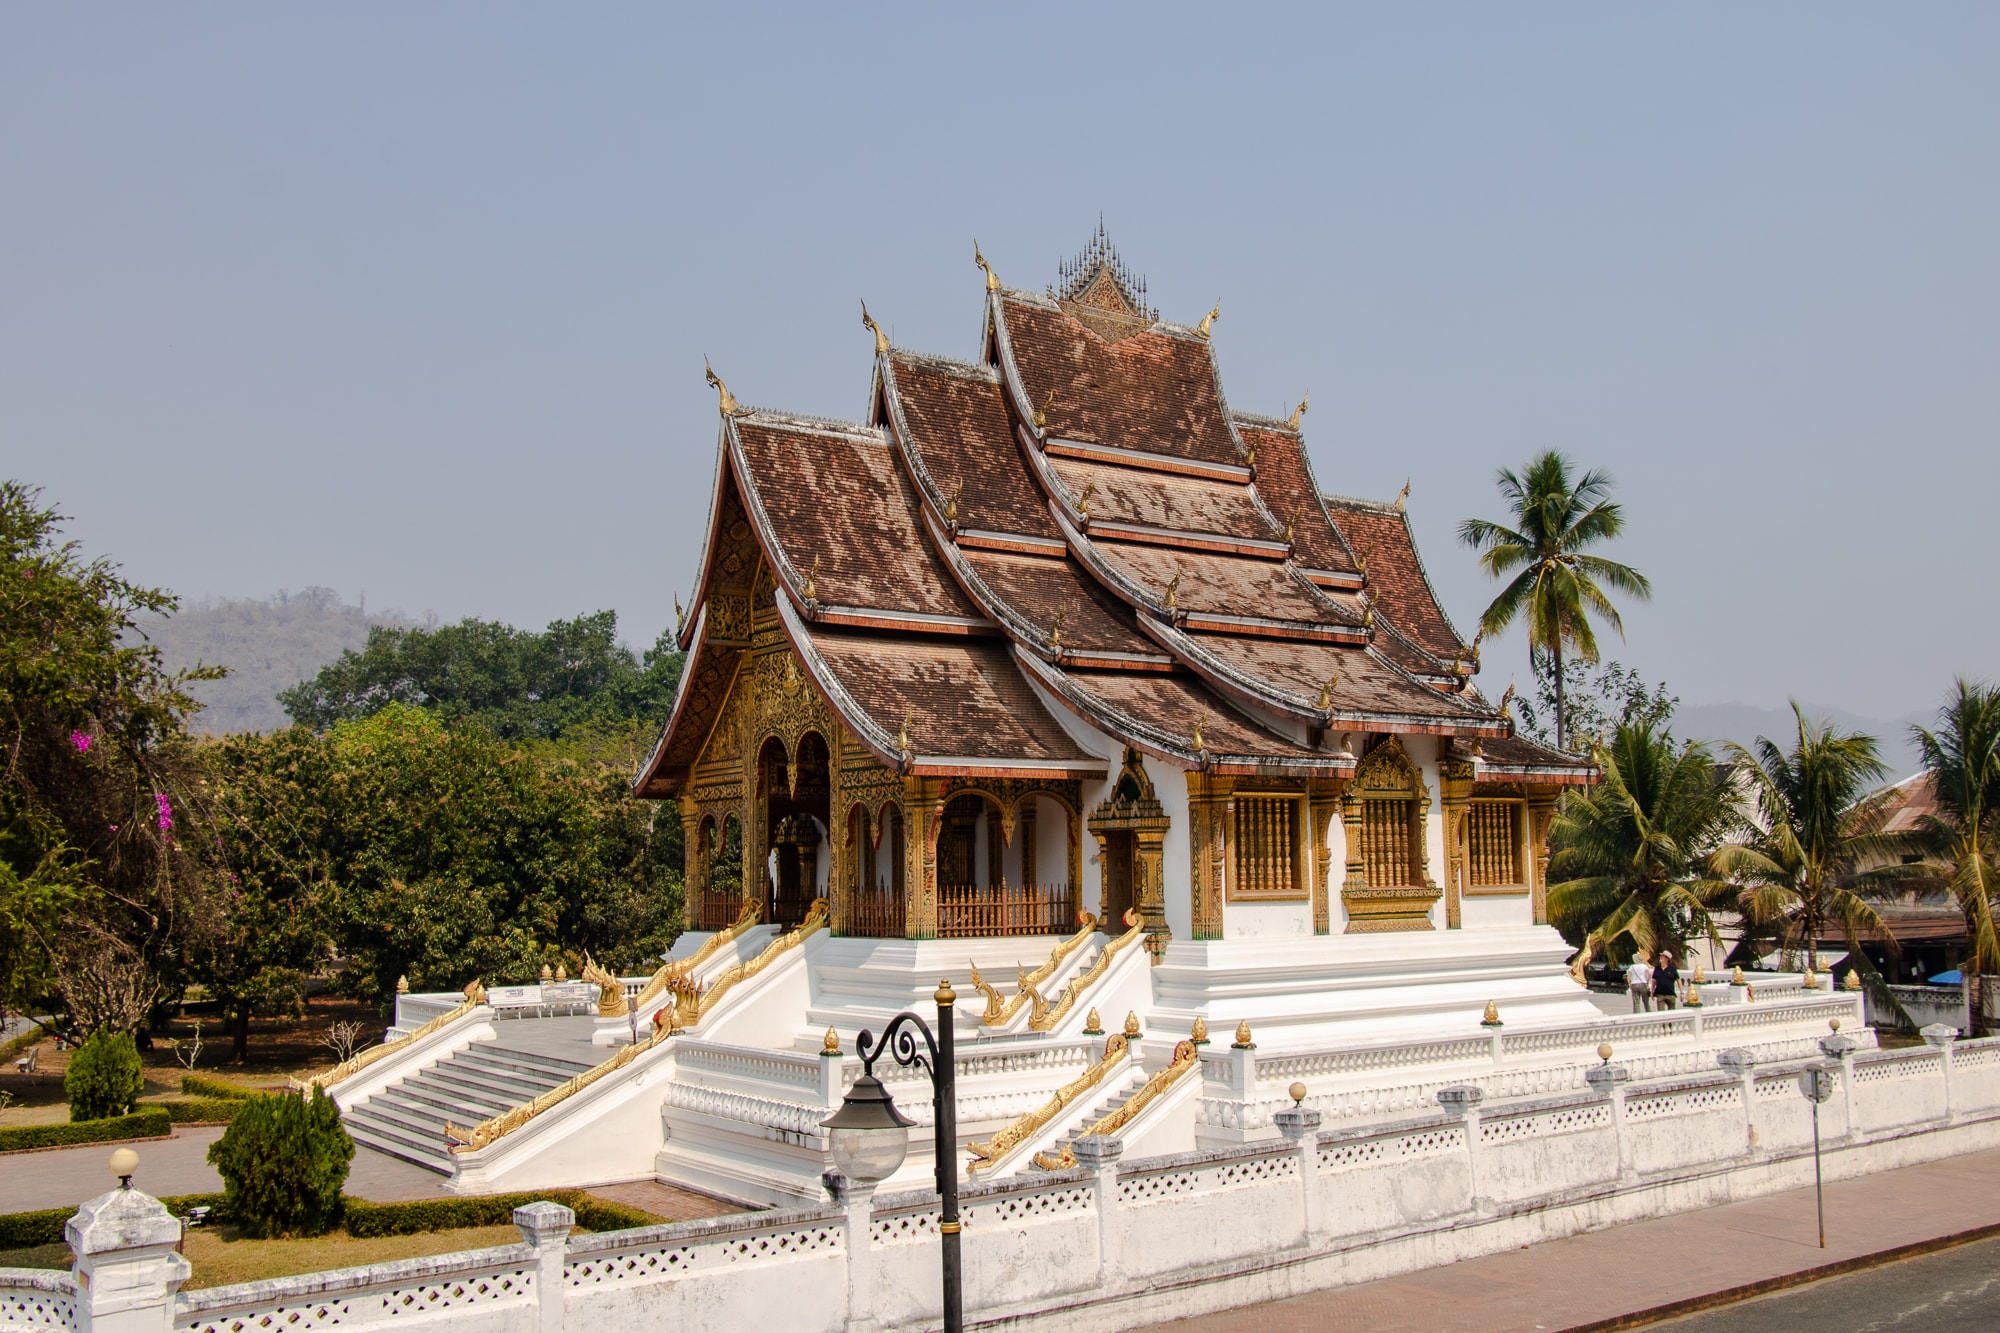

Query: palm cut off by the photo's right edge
1910 677 2000 1029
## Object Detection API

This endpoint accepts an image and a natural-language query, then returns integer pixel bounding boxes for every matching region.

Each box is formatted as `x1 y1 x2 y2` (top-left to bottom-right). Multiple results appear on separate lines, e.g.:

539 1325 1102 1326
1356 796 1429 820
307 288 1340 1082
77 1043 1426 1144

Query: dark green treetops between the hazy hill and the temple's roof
278 610 682 741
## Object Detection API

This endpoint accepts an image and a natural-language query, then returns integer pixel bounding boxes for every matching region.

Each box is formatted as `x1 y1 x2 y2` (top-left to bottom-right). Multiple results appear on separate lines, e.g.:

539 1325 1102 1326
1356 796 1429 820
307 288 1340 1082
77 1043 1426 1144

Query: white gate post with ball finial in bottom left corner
62 1177 190 1333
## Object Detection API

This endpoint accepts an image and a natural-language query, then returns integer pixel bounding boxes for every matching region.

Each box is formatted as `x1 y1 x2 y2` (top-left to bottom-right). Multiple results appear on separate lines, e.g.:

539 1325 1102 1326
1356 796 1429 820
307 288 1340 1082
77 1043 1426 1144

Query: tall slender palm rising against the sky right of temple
1458 448 1652 751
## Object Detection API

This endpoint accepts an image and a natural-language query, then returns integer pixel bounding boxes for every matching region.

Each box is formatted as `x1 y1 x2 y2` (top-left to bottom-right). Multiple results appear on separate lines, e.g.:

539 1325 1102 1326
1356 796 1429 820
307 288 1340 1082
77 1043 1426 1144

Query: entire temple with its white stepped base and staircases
332 230 1858 1203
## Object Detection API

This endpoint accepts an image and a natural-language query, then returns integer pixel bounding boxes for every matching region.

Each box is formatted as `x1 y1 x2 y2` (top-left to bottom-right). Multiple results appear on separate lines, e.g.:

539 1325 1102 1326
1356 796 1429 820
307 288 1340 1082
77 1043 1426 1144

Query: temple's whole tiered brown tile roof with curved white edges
638 234 1588 797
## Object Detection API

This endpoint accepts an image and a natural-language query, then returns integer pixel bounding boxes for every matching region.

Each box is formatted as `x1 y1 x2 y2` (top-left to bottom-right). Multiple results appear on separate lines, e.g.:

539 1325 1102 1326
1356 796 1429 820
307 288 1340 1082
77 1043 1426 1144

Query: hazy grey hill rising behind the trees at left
140 588 416 735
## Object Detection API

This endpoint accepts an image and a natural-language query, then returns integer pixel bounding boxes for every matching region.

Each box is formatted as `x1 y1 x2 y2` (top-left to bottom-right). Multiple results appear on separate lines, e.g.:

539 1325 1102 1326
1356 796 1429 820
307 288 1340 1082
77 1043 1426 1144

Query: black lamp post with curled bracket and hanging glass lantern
820 979 966 1333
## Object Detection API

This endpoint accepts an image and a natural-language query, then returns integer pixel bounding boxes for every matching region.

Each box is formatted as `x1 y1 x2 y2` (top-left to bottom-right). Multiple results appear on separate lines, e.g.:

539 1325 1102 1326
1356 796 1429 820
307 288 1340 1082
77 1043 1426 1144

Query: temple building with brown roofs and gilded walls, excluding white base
636 230 1590 969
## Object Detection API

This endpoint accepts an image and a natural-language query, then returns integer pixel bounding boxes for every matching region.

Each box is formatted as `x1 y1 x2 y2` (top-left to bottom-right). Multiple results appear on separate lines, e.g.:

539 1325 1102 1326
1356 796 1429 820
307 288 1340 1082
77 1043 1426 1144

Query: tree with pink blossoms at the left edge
0 480 222 1007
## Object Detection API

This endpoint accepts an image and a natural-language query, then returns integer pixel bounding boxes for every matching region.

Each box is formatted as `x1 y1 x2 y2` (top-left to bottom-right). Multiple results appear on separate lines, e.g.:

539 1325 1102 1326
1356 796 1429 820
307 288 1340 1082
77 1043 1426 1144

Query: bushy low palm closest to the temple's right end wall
1548 721 1736 971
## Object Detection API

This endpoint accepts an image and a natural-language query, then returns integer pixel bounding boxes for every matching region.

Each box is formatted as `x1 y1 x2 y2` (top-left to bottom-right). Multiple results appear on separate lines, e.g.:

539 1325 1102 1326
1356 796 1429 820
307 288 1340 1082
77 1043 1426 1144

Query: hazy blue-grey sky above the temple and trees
0 0 2000 717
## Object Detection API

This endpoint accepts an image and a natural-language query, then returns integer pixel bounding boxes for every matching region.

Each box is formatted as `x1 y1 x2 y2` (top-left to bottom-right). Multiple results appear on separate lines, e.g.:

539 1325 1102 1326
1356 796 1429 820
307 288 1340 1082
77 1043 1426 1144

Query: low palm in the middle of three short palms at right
1710 703 1908 971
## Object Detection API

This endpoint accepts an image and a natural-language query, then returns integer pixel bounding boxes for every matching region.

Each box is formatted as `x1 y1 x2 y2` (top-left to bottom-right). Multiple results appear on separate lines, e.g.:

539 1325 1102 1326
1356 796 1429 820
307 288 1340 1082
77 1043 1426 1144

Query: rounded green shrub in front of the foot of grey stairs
208 1089 354 1237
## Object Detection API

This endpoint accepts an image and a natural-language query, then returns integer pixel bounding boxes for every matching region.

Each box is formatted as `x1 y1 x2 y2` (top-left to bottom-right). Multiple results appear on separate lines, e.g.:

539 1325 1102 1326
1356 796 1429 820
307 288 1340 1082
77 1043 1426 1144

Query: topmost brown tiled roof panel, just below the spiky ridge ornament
996 292 1242 464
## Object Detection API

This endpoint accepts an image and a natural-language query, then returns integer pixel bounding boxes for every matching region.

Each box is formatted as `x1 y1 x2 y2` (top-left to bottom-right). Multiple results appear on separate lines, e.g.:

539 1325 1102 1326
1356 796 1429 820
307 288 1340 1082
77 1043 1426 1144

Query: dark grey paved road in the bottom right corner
1646 1239 2000 1333
